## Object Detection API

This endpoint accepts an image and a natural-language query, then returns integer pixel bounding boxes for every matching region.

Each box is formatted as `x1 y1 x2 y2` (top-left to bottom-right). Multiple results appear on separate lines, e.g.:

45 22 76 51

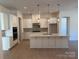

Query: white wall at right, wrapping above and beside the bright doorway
60 9 78 40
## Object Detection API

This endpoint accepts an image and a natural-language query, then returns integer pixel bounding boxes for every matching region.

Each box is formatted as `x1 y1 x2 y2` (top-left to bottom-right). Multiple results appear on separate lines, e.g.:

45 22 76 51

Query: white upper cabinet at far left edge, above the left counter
0 13 9 30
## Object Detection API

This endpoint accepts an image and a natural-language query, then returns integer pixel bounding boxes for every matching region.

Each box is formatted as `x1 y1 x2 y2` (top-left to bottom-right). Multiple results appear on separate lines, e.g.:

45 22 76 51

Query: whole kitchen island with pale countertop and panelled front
30 33 69 48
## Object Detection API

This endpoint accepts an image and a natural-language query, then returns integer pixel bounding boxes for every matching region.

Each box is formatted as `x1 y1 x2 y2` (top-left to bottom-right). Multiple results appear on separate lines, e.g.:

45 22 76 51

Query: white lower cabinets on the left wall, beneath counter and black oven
2 37 17 50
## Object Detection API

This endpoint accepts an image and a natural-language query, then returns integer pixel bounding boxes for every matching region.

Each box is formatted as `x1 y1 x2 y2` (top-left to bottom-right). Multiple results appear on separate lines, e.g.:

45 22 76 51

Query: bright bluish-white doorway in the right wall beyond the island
59 17 70 36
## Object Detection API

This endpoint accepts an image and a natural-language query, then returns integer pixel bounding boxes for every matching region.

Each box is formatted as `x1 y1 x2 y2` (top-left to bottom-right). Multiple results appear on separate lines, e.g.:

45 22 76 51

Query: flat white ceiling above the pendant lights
0 0 78 14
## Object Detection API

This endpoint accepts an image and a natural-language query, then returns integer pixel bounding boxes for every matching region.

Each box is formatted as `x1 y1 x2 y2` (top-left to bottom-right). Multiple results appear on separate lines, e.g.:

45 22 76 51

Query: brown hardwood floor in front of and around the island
4 40 78 59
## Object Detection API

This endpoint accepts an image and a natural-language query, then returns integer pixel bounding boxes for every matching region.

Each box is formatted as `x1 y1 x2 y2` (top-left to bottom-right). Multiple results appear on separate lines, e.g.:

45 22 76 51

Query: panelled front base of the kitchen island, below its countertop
30 37 68 48
